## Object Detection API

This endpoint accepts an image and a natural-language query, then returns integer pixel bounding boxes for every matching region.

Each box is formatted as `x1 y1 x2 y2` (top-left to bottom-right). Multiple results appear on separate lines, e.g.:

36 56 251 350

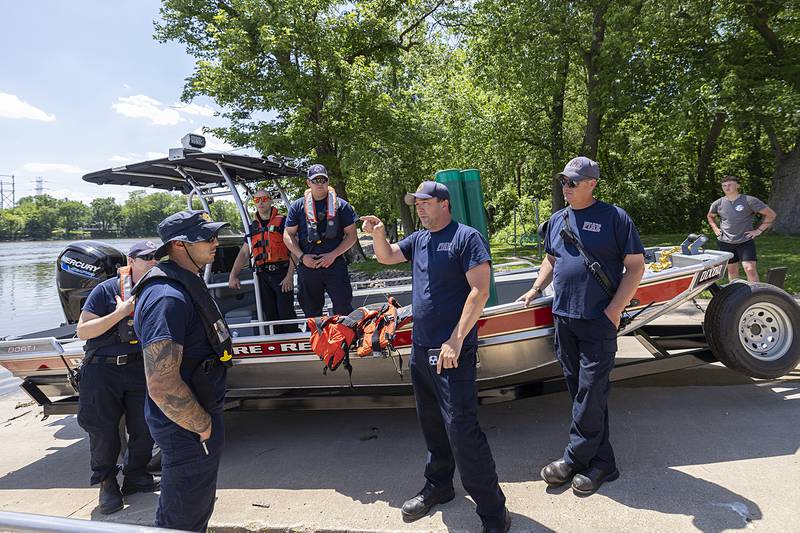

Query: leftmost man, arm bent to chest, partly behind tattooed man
77 241 158 514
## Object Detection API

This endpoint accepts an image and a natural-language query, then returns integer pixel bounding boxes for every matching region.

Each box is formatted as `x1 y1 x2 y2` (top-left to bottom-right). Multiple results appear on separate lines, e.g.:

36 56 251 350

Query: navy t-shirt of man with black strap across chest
544 200 644 319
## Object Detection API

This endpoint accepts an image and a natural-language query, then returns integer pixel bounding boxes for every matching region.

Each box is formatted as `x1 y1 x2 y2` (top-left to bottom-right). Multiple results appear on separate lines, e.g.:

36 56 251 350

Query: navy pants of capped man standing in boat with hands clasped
297 256 353 318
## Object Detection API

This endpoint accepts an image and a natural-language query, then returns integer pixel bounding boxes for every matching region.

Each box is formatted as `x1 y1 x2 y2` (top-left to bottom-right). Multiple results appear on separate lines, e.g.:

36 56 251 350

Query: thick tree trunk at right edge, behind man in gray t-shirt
769 139 800 235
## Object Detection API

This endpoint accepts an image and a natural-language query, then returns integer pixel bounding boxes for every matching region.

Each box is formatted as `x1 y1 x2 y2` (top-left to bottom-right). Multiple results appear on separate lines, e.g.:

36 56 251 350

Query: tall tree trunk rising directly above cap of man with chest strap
581 2 608 160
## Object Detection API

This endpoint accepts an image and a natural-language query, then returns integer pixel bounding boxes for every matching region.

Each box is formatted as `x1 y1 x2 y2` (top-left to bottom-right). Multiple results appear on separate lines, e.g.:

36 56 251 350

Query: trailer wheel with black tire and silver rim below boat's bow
703 283 800 379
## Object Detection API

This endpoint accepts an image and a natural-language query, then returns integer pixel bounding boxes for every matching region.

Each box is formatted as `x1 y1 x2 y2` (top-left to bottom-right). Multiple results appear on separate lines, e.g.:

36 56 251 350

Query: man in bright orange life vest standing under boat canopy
228 189 297 333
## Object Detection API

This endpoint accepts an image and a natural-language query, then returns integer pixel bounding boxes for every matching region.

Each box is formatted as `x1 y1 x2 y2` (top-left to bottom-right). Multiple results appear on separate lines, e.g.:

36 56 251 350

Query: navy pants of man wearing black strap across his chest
553 315 617 471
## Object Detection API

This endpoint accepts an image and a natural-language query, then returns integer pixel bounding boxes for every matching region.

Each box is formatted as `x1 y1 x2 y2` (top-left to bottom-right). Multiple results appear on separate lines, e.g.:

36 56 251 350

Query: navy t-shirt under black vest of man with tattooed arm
134 279 226 433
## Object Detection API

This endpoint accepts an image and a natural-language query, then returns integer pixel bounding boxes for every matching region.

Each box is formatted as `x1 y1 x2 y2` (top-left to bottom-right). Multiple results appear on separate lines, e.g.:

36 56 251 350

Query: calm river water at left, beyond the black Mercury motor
0 239 152 337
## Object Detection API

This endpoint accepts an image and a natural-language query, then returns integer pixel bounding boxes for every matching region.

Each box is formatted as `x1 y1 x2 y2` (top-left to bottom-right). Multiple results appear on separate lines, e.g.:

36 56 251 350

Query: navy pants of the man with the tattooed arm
154 413 225 531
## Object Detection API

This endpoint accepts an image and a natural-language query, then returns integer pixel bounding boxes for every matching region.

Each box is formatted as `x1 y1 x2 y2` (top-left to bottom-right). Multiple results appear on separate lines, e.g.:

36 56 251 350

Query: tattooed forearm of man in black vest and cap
144 340 211 433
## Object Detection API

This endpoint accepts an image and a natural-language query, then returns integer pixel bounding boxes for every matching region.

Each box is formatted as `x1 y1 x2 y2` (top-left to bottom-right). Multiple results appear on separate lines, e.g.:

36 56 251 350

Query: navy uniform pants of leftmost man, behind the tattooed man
78 355 153 485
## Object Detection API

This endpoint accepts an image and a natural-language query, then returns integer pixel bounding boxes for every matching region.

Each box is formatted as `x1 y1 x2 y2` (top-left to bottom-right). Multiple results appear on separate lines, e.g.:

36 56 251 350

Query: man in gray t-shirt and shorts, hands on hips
706 176 775 281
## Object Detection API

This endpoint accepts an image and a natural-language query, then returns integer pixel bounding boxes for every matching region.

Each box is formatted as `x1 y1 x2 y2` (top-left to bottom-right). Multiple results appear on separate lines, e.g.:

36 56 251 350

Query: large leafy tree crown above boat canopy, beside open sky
156 0 444 256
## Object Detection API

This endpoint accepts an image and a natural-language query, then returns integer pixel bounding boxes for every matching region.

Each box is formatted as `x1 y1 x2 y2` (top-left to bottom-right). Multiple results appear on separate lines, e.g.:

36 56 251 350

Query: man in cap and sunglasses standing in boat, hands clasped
283 164 358 317
